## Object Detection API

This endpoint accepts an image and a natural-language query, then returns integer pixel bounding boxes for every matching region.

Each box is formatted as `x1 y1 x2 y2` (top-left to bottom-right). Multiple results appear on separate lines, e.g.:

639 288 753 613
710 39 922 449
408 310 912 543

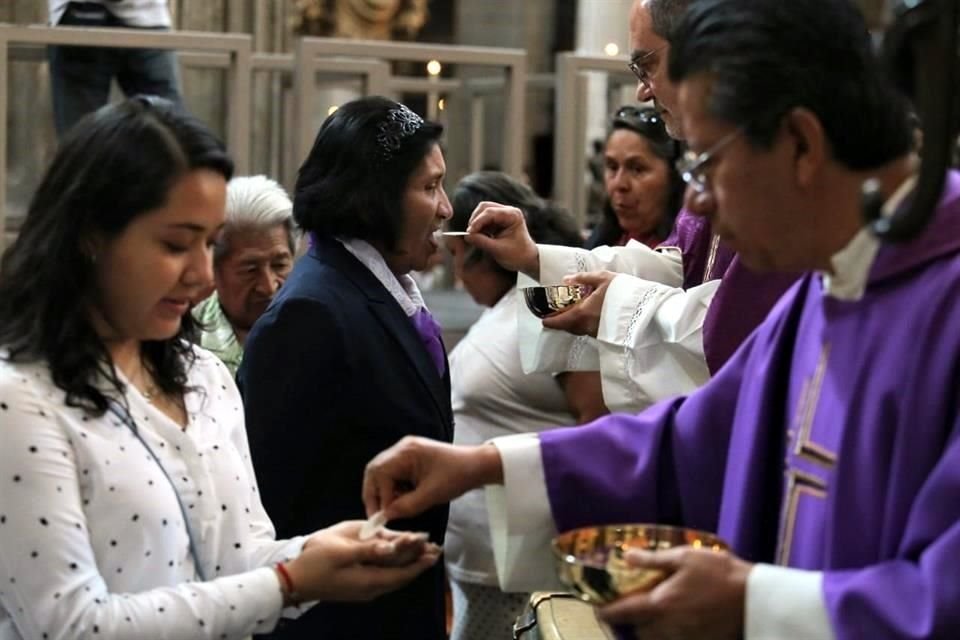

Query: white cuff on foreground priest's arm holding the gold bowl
744 564 834 640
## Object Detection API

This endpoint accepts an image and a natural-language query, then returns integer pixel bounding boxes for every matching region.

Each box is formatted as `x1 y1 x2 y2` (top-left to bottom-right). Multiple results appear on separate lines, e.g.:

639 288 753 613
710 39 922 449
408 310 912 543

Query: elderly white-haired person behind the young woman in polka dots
193 176 299 375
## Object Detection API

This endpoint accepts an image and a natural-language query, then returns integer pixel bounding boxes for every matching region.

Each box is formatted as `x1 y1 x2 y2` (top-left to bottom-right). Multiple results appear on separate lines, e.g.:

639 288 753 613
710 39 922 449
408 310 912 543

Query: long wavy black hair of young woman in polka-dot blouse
0 96 233 415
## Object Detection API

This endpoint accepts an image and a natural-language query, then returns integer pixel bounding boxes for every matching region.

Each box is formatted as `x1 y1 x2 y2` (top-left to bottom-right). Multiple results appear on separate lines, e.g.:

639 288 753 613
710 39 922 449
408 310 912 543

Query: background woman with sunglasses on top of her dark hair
587 105 684 248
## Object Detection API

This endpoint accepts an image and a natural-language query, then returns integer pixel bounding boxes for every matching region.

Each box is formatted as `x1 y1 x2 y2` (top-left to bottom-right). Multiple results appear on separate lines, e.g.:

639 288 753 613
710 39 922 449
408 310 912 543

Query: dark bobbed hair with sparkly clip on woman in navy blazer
293 96 443 251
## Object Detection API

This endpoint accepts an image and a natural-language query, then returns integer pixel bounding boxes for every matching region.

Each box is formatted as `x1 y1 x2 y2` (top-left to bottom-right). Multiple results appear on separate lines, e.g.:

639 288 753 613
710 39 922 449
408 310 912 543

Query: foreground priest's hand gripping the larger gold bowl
600 547 753 640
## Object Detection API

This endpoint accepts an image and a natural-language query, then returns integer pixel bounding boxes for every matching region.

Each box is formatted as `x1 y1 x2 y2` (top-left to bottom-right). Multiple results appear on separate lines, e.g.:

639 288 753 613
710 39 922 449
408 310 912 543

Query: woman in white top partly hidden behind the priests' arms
444 171 606 640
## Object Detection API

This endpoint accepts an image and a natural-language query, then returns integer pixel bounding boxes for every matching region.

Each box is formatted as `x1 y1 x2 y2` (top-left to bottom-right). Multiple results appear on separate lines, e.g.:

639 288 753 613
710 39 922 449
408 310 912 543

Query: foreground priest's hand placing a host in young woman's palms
363 436 503 520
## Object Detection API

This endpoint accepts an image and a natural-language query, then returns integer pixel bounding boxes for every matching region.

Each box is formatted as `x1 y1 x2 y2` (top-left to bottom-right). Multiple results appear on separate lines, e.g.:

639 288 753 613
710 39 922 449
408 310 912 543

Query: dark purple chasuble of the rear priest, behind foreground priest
660 209 798 375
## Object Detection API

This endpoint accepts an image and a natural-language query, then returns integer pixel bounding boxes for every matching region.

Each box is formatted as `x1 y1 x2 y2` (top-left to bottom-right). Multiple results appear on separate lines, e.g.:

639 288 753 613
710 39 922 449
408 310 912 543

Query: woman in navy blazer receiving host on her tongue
239 97 453 640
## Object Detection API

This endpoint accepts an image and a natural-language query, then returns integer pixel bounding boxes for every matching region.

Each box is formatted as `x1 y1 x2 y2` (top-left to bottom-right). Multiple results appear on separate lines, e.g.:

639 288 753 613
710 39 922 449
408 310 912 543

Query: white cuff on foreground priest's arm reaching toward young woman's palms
486 433 562 591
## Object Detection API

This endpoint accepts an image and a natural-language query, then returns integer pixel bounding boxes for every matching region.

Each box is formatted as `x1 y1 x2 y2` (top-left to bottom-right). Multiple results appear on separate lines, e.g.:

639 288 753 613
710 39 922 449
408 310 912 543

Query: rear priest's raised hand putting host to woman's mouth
464 202 540 284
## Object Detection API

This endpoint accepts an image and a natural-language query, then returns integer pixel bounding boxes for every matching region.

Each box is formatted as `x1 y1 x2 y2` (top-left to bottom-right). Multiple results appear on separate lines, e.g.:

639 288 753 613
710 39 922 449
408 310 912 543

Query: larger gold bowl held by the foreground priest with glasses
552 524 729 604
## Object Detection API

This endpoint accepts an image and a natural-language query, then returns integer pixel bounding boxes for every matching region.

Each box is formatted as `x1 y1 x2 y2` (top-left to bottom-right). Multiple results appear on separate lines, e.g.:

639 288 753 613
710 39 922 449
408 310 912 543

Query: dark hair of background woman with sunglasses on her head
587 105 684 249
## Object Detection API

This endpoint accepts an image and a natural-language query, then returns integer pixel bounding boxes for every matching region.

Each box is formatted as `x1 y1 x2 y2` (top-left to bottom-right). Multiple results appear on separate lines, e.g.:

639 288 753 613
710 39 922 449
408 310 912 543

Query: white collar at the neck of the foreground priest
820 176 917 302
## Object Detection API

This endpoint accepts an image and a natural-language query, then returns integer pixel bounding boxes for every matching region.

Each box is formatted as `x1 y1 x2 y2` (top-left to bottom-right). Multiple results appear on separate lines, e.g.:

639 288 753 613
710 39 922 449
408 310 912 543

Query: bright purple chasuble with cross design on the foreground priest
540 172 960 640
